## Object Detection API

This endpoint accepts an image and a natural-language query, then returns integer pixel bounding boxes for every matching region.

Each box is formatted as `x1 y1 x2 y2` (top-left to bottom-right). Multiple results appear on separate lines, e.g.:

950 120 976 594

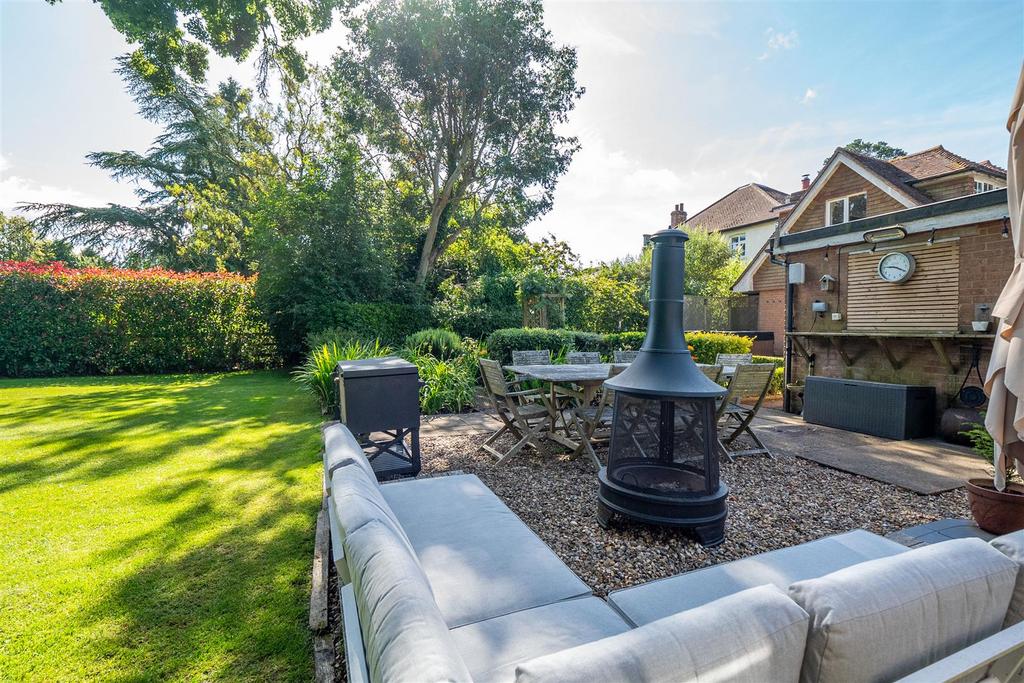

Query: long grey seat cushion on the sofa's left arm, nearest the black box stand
381 474 591 628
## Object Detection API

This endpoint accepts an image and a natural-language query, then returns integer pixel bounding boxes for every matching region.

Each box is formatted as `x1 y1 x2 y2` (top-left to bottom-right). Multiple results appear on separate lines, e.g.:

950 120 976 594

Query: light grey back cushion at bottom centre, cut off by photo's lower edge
515 586 808 683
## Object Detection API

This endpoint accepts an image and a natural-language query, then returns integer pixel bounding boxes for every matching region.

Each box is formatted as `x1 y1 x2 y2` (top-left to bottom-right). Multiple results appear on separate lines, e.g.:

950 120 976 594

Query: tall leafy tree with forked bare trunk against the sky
334 0 583 285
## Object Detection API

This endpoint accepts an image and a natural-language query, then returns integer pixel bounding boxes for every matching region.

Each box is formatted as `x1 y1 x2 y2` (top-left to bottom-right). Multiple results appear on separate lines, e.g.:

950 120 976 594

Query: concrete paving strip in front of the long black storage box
752 410 990 495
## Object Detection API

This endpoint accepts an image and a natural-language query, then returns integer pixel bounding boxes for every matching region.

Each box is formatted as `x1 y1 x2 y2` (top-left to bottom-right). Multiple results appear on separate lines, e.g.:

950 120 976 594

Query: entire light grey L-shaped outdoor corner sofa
324 424 1024 683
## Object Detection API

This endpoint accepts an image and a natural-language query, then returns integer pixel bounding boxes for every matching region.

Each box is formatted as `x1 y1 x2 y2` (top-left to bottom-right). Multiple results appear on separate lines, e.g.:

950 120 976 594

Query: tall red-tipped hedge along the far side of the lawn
0 261 280 377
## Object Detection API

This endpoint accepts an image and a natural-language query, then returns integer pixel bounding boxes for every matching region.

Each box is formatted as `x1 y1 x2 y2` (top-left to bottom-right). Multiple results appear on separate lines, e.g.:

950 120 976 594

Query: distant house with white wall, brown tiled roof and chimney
670 182 790 261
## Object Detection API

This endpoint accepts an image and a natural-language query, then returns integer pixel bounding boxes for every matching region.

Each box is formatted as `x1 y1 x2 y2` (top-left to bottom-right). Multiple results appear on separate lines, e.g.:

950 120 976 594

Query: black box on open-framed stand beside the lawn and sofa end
335 356 420 479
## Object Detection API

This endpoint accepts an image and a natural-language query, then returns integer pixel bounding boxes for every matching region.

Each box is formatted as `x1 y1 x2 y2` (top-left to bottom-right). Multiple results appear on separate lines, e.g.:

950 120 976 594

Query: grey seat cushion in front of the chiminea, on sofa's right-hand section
608 529 907 626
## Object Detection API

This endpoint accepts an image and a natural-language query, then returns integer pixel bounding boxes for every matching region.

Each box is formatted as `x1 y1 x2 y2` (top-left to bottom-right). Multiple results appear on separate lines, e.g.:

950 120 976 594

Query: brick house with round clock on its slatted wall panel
733 146 1013 417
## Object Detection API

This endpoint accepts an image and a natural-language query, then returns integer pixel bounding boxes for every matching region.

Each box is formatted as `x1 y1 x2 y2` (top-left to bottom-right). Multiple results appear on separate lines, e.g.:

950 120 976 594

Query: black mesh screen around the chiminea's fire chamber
607 391 718 496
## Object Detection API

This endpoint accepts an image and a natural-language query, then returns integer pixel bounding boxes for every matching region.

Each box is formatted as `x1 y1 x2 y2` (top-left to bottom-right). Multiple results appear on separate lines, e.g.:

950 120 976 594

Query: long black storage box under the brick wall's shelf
804 376 935 439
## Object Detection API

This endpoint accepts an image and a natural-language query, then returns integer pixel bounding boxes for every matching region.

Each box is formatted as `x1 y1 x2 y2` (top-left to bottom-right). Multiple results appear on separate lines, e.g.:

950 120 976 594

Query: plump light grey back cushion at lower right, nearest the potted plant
790 539 1017 683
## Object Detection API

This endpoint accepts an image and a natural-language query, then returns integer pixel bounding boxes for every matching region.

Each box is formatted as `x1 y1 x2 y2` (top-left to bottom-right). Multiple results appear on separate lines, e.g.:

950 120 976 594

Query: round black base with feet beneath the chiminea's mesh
597 467 729 548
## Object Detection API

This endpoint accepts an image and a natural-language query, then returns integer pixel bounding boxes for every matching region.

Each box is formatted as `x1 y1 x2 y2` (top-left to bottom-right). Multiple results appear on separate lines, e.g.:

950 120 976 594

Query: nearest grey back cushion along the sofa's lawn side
344 520 470 683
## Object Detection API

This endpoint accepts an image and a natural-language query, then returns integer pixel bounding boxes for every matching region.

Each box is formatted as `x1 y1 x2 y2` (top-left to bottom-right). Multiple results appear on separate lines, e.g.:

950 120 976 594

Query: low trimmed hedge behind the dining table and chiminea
486 328 754 365
